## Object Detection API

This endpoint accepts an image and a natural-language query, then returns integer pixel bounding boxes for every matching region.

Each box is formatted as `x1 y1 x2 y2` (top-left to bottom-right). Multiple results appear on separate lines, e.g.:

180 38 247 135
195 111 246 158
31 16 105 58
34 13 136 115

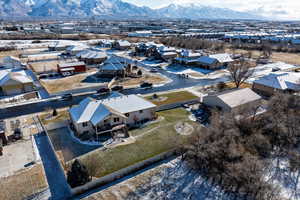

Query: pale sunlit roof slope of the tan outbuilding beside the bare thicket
217 88 261 108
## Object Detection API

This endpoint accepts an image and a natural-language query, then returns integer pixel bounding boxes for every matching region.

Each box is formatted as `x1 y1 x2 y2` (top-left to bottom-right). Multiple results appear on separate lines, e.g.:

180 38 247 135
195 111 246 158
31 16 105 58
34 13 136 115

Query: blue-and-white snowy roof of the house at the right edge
254 72 300 91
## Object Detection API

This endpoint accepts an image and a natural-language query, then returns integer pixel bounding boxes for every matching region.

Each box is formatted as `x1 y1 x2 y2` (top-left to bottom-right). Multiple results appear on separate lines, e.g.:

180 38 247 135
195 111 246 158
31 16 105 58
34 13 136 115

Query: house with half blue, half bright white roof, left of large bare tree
197 53 234 69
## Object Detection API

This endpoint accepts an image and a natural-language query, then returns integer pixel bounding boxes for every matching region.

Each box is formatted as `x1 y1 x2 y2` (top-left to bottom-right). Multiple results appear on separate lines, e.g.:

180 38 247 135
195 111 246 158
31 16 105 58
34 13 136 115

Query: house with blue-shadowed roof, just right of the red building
98 55 133 78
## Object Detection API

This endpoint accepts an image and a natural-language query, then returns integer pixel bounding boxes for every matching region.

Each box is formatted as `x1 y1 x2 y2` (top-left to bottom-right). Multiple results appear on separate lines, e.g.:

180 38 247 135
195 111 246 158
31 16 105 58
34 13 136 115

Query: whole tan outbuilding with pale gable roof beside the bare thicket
202 88 262 112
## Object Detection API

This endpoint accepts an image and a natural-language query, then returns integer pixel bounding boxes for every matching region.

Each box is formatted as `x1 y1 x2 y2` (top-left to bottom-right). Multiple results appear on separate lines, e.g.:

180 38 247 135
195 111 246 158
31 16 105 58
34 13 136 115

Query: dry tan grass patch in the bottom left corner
0 164 48 200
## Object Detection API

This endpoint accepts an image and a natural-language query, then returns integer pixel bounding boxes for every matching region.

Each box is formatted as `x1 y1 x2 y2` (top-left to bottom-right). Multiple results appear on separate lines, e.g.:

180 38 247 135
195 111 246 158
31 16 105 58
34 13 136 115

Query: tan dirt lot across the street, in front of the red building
40 69 104 94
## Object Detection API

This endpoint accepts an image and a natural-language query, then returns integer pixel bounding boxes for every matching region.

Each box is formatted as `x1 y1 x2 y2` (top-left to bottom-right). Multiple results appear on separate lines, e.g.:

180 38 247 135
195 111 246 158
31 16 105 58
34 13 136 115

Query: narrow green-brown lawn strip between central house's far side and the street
146 91 198 106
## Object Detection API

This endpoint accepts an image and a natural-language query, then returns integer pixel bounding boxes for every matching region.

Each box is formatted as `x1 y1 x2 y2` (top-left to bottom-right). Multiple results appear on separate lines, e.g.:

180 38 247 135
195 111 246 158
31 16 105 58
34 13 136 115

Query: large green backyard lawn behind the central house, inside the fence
69 108 199 177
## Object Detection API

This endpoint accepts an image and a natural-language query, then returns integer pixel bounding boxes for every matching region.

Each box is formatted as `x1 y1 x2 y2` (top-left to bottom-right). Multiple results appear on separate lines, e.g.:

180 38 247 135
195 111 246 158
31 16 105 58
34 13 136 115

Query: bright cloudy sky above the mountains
123 0 300 20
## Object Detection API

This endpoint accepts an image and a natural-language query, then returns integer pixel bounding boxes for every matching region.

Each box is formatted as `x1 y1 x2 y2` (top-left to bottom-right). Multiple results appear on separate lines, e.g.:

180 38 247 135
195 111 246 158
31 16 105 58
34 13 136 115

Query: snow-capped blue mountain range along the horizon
0 0 261 19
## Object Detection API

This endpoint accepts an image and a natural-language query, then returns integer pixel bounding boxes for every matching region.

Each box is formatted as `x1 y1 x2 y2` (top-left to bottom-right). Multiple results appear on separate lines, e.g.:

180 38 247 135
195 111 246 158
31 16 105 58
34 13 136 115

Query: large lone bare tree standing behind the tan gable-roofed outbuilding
228 59 254 88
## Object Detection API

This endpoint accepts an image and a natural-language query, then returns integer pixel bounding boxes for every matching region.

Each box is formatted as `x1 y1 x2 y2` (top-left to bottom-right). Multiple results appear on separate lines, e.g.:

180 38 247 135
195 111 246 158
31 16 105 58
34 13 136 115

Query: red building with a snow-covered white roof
57 62 86 74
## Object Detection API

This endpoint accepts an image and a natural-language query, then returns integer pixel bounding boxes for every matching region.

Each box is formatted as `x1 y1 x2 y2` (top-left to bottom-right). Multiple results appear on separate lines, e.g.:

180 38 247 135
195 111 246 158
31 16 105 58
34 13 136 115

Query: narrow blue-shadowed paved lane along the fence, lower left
35 132 71 200
